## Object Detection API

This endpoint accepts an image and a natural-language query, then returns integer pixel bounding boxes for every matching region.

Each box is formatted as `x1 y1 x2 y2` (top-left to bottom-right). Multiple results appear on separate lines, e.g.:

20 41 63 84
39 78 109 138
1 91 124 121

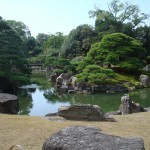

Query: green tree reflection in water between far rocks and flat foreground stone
44 90 122 112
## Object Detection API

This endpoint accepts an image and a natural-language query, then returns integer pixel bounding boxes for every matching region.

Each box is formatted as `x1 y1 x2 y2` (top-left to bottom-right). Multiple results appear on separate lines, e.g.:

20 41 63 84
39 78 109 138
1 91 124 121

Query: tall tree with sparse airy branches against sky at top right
89 0 149 37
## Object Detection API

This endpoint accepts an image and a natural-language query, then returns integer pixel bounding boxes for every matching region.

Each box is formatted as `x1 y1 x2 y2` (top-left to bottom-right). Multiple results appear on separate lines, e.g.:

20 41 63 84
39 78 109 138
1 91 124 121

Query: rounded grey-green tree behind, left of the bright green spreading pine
61 24 96 58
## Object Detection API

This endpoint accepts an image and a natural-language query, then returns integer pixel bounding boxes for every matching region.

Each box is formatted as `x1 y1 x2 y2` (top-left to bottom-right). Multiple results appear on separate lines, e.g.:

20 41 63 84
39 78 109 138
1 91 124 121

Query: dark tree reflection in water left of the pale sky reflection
18 88 33 115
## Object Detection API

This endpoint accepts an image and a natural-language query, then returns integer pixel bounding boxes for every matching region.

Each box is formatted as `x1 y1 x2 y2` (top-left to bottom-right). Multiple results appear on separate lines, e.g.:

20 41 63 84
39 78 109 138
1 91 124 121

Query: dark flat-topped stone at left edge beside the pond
0 93 19 114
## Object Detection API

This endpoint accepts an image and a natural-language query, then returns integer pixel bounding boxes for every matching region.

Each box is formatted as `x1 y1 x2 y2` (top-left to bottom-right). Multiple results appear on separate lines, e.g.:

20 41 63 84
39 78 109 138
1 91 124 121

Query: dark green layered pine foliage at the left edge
0 19 30 84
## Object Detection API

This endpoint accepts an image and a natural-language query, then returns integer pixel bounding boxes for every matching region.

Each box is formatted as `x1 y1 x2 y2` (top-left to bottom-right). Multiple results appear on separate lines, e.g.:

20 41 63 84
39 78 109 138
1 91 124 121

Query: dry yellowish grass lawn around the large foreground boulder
0 112 150 150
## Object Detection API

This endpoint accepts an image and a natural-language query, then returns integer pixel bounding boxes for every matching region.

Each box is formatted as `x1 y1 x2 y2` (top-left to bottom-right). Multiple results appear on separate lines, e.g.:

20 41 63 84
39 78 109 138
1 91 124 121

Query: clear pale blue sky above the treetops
0 0 150 37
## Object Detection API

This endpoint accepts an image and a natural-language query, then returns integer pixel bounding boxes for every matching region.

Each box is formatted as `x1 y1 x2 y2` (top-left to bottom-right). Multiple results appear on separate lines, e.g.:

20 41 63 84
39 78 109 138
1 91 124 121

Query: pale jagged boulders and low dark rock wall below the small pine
56 73 128 93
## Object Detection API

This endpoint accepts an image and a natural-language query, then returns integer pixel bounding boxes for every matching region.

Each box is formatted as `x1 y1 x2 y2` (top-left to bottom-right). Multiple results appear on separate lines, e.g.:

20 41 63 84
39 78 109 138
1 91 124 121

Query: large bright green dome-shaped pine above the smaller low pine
79 33 146 70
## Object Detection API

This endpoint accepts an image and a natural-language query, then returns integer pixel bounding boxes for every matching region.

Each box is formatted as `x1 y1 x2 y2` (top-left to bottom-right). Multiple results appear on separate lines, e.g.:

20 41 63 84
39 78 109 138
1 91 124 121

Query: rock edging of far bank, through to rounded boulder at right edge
50 73 150 93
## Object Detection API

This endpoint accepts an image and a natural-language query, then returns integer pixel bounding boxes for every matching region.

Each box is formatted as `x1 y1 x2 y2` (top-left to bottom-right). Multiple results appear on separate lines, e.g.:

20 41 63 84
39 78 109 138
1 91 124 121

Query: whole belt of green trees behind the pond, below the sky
0 0 150 87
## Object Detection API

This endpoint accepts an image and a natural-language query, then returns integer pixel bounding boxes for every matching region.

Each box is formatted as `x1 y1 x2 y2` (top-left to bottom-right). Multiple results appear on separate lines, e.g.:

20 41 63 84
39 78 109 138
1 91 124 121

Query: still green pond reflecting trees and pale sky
18 74 150 116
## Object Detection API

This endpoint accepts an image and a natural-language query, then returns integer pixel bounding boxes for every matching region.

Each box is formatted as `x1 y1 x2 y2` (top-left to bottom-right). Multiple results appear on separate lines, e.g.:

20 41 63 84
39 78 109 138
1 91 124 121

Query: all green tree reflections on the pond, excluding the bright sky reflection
18 74 150 114
